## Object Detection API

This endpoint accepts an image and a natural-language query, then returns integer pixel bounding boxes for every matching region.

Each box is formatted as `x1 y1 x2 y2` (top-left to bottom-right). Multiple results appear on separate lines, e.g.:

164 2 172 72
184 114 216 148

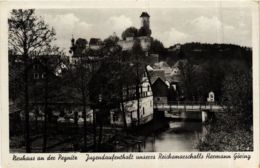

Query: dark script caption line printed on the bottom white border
12 153 251 162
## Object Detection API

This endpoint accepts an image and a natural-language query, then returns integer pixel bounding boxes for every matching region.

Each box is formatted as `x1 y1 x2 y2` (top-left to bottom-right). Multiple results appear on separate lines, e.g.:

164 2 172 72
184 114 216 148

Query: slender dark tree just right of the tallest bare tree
30 46 67 152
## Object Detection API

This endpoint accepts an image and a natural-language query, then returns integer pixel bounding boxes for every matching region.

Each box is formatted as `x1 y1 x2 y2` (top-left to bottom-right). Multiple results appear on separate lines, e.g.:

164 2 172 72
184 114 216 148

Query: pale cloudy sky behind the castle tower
36 7 252 52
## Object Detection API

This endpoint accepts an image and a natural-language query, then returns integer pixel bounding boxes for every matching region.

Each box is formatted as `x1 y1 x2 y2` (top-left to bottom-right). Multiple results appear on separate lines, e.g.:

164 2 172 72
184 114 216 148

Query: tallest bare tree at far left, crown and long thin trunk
8 9 55 152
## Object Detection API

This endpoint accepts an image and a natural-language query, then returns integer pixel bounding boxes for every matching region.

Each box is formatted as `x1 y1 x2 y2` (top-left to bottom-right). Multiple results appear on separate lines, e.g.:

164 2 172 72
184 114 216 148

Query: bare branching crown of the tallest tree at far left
8 9 55 56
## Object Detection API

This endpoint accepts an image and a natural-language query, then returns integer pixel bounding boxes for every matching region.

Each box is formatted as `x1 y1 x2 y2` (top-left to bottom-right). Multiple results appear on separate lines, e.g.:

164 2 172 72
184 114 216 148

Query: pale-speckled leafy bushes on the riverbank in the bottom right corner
196 113 253 151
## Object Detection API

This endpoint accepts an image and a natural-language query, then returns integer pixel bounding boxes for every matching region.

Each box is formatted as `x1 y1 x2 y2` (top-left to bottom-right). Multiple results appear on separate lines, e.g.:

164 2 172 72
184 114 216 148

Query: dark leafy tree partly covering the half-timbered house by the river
89 38 145 129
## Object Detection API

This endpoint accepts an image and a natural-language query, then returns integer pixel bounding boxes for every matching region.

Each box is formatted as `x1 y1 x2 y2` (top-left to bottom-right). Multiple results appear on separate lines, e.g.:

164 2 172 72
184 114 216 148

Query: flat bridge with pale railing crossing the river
154 101 224 112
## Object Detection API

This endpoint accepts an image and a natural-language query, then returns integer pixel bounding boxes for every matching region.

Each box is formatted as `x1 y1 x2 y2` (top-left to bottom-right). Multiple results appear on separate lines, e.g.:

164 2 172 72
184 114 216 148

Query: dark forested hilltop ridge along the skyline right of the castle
160 43 252 67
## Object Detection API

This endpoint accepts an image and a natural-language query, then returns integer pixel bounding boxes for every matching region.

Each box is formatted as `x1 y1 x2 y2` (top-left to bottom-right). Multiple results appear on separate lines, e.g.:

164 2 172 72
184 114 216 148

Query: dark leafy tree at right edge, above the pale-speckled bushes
222 70 253 126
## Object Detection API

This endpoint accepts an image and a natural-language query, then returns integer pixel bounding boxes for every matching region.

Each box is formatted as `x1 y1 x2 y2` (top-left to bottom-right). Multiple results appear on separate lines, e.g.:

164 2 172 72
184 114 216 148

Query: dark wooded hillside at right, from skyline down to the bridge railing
156 43 252 100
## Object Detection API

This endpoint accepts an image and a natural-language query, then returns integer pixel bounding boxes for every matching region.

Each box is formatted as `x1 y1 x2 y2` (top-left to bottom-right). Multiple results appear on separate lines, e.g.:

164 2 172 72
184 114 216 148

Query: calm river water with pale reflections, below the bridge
121 121 205 152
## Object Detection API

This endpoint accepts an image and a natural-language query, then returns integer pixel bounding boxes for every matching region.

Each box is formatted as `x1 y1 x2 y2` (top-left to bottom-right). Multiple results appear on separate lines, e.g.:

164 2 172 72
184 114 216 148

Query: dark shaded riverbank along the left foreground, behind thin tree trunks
10 120 168 153
